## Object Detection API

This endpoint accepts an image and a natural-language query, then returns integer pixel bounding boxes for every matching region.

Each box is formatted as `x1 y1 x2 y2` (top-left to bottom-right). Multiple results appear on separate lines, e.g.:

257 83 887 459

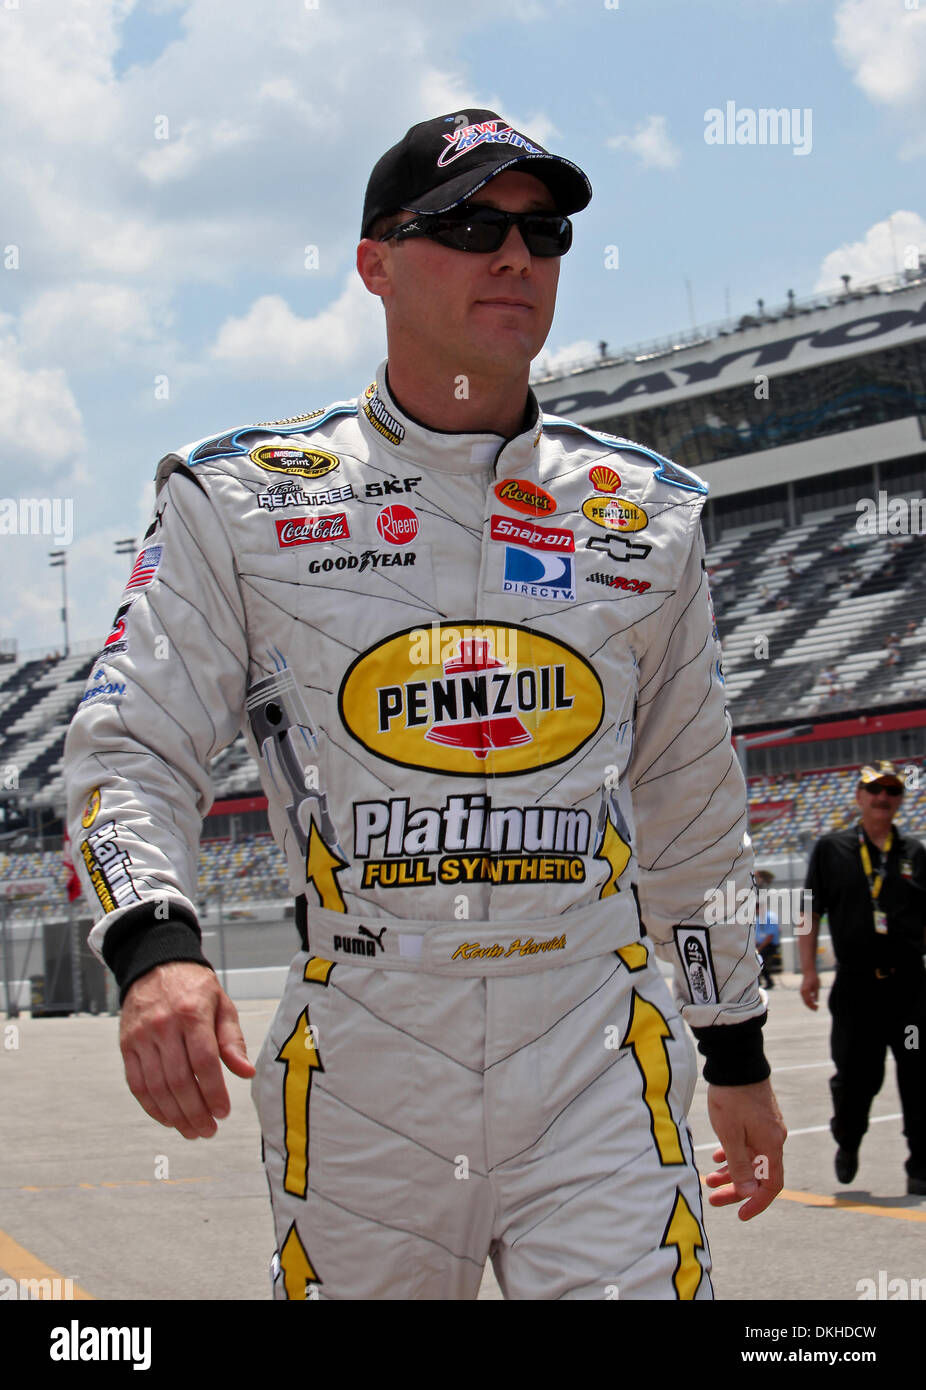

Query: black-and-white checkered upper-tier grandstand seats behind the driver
0 505 926 810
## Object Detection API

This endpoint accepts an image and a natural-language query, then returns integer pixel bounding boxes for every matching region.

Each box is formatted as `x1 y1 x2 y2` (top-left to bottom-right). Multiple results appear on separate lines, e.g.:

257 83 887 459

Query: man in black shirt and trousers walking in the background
798 762 926 1195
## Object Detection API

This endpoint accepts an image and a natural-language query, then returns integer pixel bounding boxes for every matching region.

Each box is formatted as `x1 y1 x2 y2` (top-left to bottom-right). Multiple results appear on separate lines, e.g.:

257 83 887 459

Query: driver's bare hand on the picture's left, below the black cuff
120 960 254 1138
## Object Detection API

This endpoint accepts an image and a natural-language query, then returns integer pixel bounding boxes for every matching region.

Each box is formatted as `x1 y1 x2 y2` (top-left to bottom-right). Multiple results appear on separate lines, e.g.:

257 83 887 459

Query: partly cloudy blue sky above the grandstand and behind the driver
0 0 926 651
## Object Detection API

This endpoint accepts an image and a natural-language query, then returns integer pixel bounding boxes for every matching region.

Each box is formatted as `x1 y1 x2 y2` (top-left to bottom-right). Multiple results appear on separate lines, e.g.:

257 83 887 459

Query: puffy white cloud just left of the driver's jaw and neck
211 270 385 377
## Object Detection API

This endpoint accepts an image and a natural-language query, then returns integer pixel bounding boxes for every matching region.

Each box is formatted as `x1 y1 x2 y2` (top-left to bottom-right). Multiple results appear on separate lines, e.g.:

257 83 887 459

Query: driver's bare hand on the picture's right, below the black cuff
705 1080 788 1220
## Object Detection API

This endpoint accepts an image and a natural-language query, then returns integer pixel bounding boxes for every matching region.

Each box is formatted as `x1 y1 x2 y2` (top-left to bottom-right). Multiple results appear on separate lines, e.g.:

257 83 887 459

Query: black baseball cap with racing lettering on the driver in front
360 110 591 236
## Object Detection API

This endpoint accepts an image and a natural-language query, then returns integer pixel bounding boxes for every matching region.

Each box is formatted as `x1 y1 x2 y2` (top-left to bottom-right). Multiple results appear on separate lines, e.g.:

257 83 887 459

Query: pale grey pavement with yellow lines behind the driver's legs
0 967 926 1311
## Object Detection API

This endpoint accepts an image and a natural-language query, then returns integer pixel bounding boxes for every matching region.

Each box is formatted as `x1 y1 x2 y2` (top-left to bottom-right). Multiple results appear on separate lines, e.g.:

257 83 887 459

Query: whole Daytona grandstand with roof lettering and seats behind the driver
0 264 926 912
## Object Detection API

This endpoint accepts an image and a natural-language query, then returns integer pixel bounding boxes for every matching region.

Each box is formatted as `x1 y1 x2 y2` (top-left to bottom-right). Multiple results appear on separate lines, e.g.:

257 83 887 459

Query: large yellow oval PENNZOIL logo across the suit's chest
338 620 605 778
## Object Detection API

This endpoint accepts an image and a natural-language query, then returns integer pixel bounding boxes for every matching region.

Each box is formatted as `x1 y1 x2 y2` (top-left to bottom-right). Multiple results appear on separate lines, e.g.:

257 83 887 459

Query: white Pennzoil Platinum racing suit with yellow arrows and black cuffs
67 363 767 1300
